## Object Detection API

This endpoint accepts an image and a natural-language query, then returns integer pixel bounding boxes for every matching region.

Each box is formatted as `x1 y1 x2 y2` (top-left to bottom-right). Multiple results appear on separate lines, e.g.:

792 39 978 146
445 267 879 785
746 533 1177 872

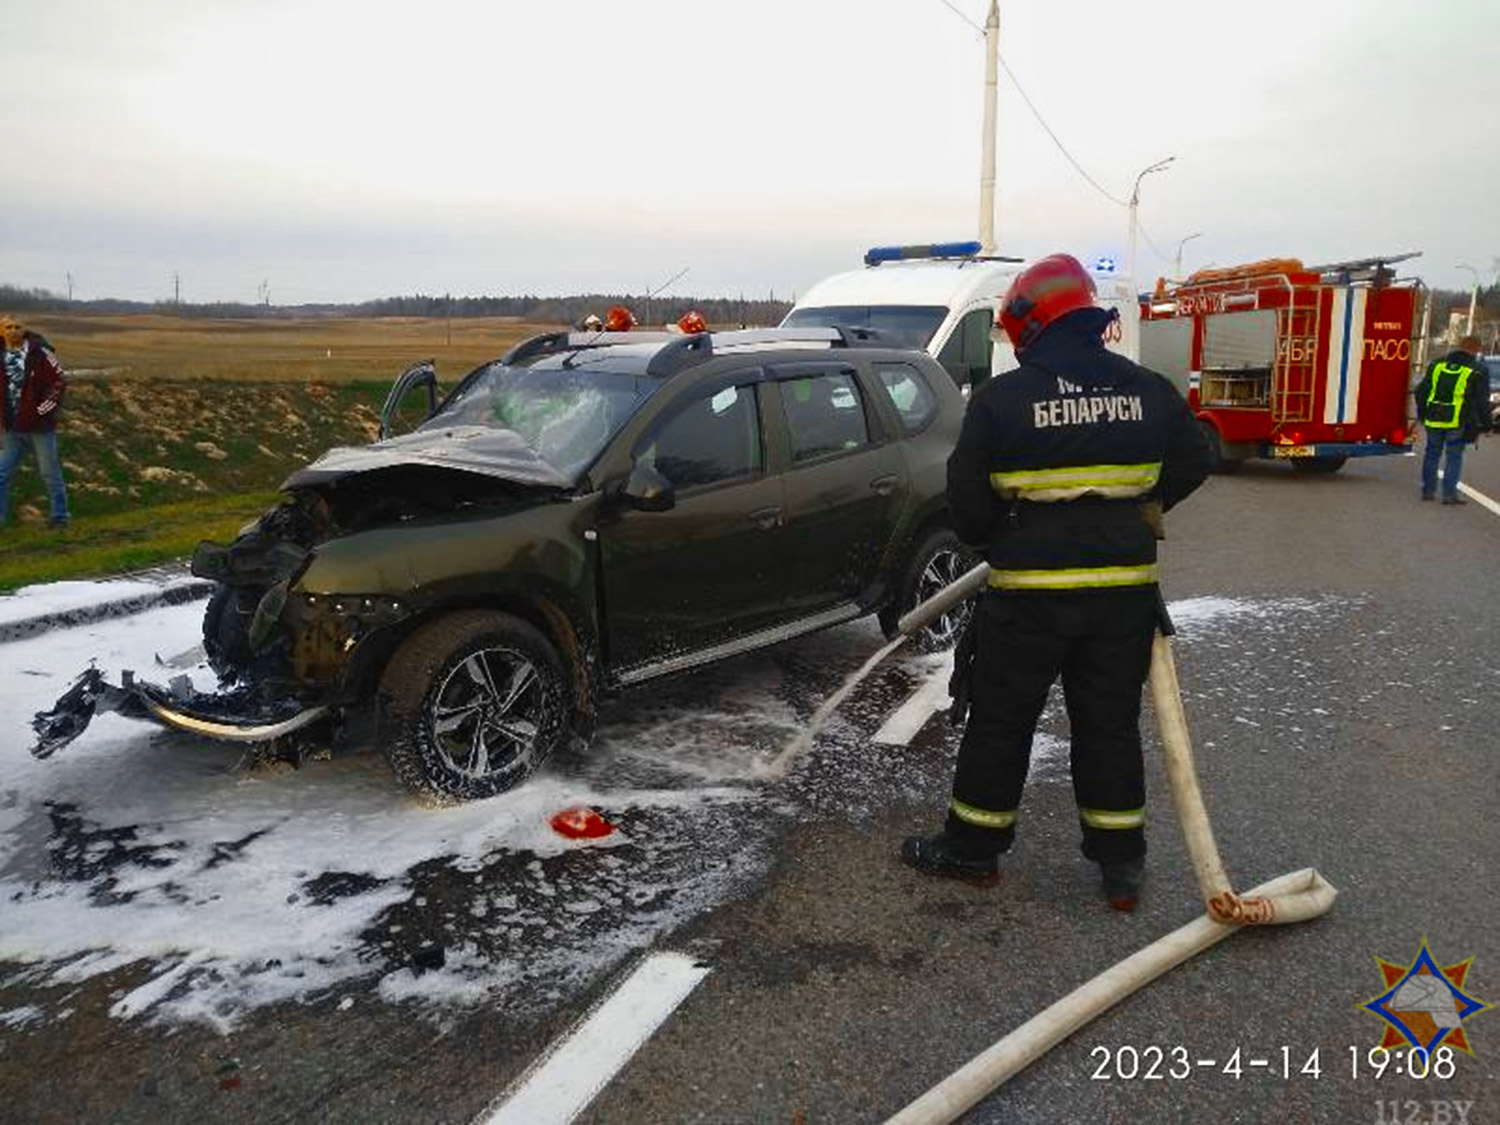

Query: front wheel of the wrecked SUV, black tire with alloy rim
377 611 572 804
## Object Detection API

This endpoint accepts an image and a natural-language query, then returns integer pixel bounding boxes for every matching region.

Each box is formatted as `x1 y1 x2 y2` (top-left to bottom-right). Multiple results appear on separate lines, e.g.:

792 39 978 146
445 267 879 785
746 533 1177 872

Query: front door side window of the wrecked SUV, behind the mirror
636 386 762 489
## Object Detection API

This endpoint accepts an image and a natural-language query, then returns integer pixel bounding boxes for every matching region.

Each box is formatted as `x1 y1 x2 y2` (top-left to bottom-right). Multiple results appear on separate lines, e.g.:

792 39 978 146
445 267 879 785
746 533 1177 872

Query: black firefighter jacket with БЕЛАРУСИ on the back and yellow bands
948 309 1209 591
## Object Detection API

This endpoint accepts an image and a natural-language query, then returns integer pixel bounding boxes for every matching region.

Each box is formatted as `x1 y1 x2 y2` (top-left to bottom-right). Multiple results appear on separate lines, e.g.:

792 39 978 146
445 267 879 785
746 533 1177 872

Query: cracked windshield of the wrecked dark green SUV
420 363 660 480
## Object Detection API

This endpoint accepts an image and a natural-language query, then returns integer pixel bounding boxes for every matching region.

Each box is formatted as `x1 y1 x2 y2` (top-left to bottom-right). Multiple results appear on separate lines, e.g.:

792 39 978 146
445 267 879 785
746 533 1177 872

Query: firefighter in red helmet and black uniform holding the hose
902 254 1209 911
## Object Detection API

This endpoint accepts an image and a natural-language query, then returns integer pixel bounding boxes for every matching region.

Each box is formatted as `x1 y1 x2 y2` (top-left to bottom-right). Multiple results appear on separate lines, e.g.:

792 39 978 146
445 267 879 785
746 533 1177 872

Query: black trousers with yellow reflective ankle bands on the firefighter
945 587 1157 864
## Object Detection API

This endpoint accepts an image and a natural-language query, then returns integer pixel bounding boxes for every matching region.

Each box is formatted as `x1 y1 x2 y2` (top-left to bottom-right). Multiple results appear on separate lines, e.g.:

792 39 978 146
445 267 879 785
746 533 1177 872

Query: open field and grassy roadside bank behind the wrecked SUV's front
0 317 558 591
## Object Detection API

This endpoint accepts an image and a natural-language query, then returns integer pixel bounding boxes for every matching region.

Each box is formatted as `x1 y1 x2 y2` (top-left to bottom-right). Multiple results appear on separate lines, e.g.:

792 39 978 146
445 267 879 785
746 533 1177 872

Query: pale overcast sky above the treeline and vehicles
0 0 1500 305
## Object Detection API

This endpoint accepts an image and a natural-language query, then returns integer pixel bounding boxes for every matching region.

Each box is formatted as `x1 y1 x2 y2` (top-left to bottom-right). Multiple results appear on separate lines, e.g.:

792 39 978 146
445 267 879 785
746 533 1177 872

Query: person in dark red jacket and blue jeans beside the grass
0 315 68 530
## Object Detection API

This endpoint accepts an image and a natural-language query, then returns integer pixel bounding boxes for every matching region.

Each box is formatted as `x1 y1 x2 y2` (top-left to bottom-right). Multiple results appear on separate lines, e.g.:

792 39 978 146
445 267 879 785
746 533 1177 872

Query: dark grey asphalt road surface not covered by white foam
0 441 1500 1125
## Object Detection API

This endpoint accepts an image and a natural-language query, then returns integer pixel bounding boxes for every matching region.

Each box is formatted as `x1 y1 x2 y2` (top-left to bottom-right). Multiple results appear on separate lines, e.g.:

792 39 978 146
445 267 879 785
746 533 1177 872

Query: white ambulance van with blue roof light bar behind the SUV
782 242 1140 393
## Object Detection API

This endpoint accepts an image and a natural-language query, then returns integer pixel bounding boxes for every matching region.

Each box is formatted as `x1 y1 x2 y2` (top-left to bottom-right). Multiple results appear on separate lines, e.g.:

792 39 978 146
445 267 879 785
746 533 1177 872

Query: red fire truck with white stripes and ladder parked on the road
1140 254 1427 473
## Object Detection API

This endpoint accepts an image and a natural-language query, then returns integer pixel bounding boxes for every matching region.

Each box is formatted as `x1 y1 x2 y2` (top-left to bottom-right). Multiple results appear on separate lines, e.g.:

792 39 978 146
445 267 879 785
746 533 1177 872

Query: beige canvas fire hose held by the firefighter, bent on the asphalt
888 563 1338 1125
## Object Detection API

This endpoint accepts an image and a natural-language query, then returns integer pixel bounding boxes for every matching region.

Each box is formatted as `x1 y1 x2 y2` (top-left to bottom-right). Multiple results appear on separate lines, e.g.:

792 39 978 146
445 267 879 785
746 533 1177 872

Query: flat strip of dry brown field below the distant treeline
29 314 564 386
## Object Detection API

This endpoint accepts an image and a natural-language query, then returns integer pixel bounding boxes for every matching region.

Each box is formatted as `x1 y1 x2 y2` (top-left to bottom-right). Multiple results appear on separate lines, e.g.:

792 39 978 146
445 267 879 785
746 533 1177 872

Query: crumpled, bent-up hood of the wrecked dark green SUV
282 426 573 489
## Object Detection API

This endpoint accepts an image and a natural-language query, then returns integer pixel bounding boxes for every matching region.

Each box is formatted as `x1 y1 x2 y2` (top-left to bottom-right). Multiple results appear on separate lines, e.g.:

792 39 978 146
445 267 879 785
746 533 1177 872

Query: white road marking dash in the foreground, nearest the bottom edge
477 953 708 1125
